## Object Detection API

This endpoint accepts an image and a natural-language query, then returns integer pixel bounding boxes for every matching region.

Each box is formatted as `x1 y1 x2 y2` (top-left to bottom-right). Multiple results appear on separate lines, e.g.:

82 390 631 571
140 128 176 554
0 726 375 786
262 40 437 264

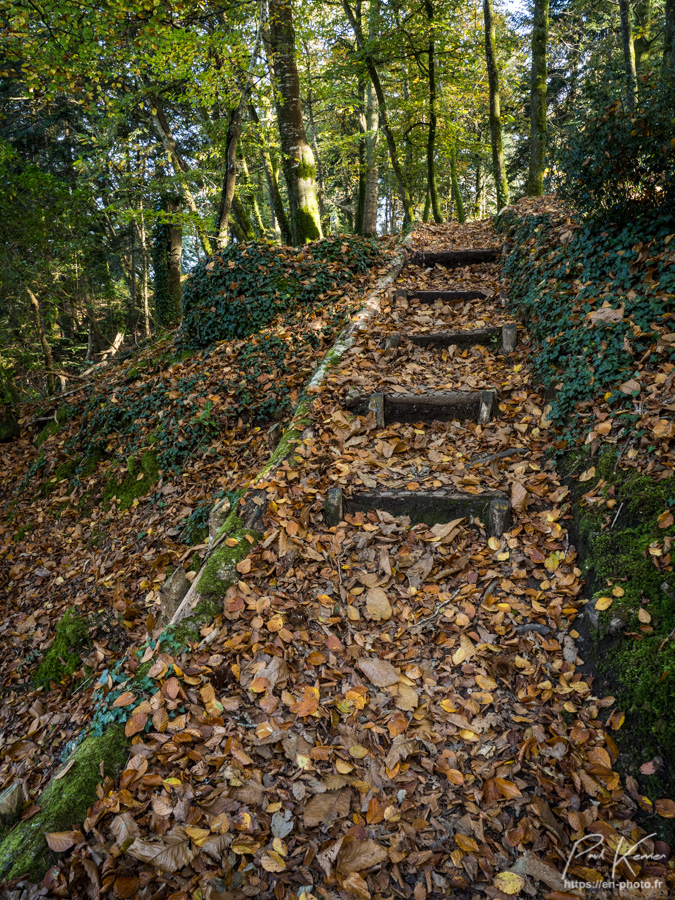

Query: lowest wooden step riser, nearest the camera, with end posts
324 487 511 537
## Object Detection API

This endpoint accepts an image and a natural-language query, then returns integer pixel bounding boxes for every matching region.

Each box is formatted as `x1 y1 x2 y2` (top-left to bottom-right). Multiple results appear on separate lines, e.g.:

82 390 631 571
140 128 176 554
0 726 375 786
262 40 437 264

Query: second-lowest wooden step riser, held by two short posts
345 391 496 428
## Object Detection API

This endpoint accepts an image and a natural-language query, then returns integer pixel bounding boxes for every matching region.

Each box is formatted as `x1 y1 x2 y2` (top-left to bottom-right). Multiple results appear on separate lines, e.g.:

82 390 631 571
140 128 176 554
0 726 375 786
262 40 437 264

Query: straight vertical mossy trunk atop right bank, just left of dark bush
527 0 549 197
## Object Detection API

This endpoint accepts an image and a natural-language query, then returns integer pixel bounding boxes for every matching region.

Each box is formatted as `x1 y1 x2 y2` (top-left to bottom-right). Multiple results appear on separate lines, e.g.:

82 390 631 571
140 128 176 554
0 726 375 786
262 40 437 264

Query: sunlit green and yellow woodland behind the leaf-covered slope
0 0 675 402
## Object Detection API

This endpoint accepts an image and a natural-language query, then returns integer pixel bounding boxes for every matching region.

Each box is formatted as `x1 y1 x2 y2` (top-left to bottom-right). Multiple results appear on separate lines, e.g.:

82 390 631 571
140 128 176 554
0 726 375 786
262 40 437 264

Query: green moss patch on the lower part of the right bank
575 451 675 840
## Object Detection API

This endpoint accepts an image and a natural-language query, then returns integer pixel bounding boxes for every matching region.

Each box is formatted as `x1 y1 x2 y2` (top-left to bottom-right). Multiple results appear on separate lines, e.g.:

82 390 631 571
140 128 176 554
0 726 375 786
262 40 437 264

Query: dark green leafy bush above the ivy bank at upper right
554 80 675 223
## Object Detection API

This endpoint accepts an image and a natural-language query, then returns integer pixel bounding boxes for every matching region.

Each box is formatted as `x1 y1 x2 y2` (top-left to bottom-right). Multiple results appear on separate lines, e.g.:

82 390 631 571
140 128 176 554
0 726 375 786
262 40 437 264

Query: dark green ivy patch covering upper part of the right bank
498 207 675 443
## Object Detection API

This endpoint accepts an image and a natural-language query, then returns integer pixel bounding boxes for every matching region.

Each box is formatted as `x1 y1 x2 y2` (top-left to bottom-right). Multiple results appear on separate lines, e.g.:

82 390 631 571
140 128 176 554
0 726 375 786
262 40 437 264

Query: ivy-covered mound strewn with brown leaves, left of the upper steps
181 235 380 349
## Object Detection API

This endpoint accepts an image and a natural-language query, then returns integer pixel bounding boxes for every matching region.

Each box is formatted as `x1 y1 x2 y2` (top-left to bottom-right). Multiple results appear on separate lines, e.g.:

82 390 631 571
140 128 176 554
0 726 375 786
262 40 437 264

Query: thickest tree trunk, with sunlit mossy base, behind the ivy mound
269 0 323 245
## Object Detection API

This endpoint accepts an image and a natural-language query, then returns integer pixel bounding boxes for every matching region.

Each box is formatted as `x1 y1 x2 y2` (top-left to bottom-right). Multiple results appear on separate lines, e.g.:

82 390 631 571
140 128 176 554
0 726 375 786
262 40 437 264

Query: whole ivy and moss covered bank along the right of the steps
498 198 675 837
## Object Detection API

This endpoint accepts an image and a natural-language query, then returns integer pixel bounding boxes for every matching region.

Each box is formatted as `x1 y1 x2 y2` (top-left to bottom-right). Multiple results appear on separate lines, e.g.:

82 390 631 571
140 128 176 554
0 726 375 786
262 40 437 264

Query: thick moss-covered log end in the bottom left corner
0 727 127 881
